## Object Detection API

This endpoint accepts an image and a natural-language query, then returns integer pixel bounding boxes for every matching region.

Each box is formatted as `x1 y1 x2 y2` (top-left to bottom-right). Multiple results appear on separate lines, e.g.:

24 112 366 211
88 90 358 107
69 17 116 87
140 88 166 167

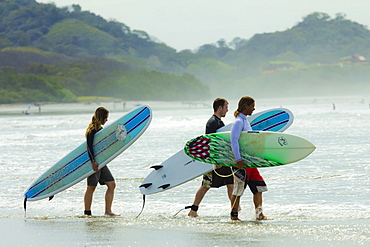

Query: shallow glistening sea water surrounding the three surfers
0 97 370 247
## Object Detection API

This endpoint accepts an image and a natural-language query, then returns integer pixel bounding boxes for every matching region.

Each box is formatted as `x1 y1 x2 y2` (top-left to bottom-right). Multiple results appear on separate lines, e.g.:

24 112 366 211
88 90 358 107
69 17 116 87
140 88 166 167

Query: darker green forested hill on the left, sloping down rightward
0 0 209 103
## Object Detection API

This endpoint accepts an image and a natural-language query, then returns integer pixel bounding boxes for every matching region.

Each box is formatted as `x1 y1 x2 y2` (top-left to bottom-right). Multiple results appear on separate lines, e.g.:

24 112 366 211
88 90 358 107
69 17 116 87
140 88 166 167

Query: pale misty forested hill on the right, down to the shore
192 13 370 97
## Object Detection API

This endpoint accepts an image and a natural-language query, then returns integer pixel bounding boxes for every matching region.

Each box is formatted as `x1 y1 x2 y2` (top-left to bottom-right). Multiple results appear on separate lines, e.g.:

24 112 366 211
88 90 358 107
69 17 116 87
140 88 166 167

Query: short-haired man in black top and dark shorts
188 98 233 217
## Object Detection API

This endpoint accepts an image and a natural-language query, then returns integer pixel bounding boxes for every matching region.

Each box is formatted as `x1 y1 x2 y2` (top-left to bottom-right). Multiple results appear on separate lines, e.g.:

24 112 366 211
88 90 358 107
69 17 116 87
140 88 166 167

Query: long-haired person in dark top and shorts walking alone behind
84 107 119 216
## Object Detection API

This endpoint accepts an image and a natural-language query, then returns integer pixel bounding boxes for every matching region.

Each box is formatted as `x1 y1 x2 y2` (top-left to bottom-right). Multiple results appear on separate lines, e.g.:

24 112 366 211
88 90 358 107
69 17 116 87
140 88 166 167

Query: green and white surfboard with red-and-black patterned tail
184 131 316 168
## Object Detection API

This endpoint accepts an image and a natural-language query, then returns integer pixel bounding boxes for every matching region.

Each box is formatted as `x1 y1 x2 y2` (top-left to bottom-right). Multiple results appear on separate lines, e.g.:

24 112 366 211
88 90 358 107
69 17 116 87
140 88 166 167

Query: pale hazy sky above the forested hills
37 0 370 51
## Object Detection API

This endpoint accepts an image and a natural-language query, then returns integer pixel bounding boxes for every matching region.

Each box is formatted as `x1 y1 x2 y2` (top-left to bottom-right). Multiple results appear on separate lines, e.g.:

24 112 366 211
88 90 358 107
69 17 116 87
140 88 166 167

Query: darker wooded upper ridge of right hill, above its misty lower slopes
227 13 370 64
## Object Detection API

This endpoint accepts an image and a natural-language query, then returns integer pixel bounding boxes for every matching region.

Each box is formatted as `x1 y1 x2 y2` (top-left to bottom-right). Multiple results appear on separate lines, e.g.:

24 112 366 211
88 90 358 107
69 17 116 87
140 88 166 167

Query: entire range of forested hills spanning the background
0 0 370 103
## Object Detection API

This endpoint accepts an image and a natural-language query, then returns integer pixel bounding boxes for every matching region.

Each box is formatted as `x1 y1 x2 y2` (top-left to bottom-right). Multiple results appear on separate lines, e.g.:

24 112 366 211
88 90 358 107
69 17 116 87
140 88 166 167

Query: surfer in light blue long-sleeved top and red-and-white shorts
230 96 267 220
